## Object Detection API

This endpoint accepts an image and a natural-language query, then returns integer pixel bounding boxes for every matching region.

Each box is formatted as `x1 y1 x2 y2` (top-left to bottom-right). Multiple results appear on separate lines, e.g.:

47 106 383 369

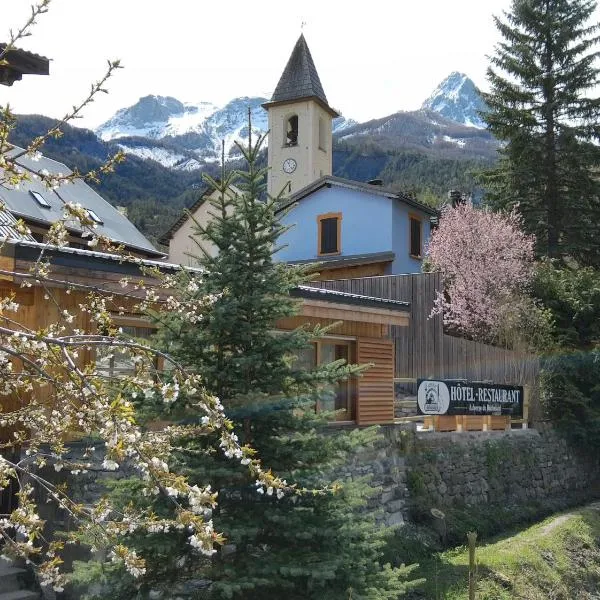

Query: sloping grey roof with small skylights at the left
0 147 163 256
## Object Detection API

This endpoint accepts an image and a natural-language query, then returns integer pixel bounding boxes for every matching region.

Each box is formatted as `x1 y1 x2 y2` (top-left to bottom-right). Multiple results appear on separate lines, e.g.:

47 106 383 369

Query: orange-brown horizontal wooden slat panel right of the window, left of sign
356 338 394 425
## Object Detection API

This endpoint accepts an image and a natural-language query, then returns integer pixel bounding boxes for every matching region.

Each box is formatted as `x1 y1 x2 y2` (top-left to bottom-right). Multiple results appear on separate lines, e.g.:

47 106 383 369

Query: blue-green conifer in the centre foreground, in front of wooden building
126 130 418 600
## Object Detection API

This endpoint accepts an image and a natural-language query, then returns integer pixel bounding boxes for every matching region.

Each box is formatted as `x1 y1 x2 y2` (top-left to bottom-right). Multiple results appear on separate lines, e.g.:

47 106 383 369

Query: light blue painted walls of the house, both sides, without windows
276 184 431 275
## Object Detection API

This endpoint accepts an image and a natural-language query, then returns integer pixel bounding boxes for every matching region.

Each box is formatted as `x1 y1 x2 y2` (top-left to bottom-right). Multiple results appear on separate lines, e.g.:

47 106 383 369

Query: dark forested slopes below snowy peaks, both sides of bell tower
11 115 492 242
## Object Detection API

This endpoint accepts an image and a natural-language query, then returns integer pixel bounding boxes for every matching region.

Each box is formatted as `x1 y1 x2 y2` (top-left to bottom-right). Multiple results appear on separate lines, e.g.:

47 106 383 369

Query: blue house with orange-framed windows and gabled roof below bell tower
277 175 436 279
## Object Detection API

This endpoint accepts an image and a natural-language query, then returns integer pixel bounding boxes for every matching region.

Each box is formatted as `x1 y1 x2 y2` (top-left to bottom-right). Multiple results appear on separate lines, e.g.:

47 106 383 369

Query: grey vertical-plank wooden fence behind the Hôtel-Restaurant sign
311 273 539 391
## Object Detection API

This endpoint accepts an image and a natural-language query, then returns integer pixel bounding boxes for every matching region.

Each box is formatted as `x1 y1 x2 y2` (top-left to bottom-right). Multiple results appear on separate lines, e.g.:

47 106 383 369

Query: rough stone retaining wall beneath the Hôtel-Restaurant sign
343 425 600 525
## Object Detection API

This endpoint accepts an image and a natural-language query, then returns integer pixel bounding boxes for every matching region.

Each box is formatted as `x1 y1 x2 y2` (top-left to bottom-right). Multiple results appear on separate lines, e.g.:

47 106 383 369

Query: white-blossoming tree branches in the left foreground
0 0 291 589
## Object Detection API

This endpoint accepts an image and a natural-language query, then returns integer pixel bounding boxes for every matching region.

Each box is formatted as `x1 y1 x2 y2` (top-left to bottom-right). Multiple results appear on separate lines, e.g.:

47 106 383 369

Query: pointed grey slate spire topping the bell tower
265 34 338 116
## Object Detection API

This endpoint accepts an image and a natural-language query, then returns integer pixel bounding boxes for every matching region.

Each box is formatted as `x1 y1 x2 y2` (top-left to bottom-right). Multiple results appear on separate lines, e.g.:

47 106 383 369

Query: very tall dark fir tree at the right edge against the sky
482 0 600 265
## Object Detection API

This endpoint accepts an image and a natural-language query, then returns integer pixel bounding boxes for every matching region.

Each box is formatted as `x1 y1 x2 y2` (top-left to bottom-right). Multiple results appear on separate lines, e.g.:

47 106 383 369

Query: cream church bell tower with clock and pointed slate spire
263 35 339 196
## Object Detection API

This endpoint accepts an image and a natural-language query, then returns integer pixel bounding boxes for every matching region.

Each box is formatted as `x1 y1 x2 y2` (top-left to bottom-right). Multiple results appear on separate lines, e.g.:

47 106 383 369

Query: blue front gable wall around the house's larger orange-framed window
277 187 392 261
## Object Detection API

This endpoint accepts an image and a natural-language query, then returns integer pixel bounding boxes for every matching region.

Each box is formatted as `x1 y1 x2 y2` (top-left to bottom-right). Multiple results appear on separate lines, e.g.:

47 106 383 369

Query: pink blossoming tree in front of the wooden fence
427 203 537 345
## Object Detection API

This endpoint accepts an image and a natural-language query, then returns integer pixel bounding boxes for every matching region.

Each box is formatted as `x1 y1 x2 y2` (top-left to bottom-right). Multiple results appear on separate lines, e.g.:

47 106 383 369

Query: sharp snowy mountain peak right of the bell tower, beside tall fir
421 71 486 129
